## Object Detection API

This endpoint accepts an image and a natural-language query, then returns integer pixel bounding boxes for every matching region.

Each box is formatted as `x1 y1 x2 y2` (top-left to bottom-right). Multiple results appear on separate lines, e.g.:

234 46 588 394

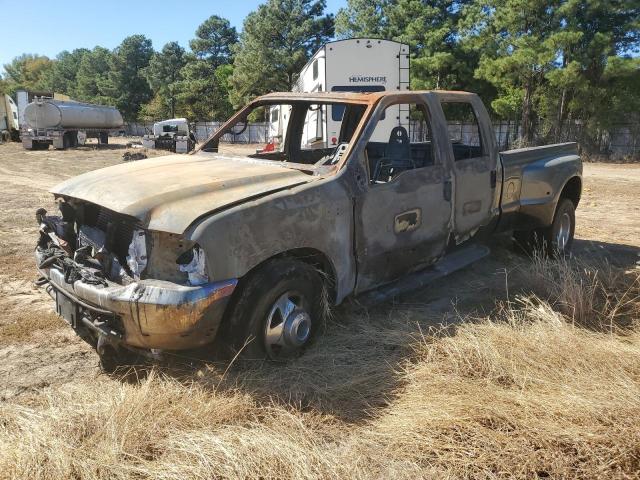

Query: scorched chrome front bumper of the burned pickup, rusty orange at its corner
35 250 238 350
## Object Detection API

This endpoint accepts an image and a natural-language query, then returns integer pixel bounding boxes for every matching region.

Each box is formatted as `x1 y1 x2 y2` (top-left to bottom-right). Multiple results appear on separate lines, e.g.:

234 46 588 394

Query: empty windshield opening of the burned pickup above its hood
202 101 366 169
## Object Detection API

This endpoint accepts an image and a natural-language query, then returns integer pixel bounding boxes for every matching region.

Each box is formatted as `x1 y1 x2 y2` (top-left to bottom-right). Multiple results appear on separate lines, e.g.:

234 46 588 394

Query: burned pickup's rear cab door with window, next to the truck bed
438 93 499 243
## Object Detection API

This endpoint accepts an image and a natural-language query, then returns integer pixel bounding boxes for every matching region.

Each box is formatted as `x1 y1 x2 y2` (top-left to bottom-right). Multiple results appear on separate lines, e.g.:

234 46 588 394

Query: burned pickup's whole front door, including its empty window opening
355 95 451 293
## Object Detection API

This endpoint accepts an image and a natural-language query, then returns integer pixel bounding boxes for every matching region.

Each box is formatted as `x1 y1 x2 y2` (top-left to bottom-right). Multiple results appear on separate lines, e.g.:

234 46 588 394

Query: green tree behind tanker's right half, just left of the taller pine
76 47 115 105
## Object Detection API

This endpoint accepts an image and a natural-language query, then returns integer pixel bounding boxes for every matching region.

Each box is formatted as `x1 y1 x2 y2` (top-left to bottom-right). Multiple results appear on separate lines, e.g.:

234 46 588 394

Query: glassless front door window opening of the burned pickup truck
366 104 435 184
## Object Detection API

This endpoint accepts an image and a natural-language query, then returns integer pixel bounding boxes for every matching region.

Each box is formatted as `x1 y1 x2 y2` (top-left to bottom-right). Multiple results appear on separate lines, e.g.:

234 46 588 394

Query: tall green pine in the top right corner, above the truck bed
542 0 640 150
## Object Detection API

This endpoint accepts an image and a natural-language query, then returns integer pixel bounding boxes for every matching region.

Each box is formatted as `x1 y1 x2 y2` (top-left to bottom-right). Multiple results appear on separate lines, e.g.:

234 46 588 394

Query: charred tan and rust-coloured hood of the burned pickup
51 153 313 234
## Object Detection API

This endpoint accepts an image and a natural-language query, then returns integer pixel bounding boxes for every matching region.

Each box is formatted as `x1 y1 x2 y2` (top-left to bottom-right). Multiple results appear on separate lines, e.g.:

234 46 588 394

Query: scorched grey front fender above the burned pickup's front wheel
185 176 356 303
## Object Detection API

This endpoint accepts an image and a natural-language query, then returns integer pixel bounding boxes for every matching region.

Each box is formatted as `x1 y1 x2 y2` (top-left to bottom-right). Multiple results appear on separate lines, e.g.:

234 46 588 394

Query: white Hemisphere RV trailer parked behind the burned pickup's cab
269 38 410 148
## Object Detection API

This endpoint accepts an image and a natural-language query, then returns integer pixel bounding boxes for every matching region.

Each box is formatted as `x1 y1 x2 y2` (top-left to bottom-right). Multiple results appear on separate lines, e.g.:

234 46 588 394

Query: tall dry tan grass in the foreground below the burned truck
0 260 640 479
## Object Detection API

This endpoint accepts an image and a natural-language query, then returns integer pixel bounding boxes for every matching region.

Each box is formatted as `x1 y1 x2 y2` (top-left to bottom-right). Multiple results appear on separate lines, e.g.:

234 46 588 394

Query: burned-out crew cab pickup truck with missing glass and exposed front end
35 91 582 368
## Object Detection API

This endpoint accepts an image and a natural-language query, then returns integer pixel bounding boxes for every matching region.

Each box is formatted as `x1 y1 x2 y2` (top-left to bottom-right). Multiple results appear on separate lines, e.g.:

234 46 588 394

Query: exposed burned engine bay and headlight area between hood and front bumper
36 198 208 286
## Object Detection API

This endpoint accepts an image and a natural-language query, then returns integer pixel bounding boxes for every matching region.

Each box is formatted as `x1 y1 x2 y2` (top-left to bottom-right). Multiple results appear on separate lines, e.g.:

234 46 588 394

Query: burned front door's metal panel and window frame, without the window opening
354 93 453 293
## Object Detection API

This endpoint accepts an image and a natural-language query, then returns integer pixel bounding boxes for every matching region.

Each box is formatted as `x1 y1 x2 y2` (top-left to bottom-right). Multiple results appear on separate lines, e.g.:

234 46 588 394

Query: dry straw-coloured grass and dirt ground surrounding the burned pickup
0 140 640 479
